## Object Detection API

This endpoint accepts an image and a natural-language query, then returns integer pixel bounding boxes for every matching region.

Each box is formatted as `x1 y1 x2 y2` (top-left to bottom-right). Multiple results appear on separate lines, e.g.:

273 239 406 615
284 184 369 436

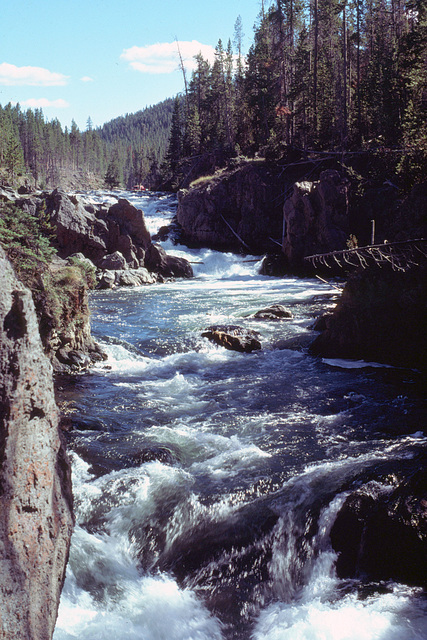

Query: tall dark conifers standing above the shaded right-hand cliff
167 0 427 184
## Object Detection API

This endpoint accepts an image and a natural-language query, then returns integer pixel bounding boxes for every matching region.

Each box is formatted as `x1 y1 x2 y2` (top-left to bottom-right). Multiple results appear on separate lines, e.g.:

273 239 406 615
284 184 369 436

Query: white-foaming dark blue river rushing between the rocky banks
54 194 427 640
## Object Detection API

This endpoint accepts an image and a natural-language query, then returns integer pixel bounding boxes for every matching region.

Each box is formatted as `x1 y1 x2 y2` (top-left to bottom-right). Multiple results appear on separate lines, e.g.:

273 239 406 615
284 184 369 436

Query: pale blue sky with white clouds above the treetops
0 0 261 130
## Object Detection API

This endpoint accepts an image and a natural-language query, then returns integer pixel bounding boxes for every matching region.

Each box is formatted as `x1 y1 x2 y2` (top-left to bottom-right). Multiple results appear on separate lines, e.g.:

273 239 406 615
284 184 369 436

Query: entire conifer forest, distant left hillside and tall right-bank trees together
0 0 427 189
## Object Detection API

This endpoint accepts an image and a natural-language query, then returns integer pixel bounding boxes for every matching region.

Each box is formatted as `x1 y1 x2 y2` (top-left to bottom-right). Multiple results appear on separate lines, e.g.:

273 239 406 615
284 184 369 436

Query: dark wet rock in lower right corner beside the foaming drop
331 455 427 587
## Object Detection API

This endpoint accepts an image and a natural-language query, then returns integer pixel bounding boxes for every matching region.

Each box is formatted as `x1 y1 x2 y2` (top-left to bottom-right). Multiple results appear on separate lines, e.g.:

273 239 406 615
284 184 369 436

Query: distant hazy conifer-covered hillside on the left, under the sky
0 99 173 188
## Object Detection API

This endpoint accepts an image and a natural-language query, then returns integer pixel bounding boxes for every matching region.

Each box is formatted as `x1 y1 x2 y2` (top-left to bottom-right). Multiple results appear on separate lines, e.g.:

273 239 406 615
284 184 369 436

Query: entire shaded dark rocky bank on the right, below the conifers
177 159 427 367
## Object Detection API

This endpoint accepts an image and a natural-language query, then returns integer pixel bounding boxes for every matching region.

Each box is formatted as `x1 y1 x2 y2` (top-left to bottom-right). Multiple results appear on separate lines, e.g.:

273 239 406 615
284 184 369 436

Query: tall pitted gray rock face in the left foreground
0 248 73 640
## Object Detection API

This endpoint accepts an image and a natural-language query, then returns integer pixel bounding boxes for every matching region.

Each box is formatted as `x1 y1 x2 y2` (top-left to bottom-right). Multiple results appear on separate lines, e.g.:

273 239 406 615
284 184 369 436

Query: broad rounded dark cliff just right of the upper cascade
177 161 284 253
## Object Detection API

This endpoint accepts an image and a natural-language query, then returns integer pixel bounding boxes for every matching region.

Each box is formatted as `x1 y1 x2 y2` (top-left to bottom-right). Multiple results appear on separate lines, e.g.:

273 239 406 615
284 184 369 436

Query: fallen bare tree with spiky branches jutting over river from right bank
304 238 427 271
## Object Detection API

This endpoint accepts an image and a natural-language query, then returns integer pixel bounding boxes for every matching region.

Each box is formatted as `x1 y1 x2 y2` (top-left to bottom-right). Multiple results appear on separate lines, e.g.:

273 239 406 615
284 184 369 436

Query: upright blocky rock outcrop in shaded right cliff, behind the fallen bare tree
282 169 350 269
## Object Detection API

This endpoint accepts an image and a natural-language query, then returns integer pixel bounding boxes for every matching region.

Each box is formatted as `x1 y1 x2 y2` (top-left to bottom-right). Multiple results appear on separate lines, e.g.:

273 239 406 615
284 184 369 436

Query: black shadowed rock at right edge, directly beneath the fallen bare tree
310 267 427 368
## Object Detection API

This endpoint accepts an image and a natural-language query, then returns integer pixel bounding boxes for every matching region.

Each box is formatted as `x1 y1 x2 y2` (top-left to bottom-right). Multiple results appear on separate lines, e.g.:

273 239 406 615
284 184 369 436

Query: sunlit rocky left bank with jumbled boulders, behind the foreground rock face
0 189 193 372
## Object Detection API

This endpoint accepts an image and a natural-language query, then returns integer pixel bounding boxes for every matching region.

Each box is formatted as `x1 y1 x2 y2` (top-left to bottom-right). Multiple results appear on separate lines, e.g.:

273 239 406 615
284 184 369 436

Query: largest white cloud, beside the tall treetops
120 40 215 73
